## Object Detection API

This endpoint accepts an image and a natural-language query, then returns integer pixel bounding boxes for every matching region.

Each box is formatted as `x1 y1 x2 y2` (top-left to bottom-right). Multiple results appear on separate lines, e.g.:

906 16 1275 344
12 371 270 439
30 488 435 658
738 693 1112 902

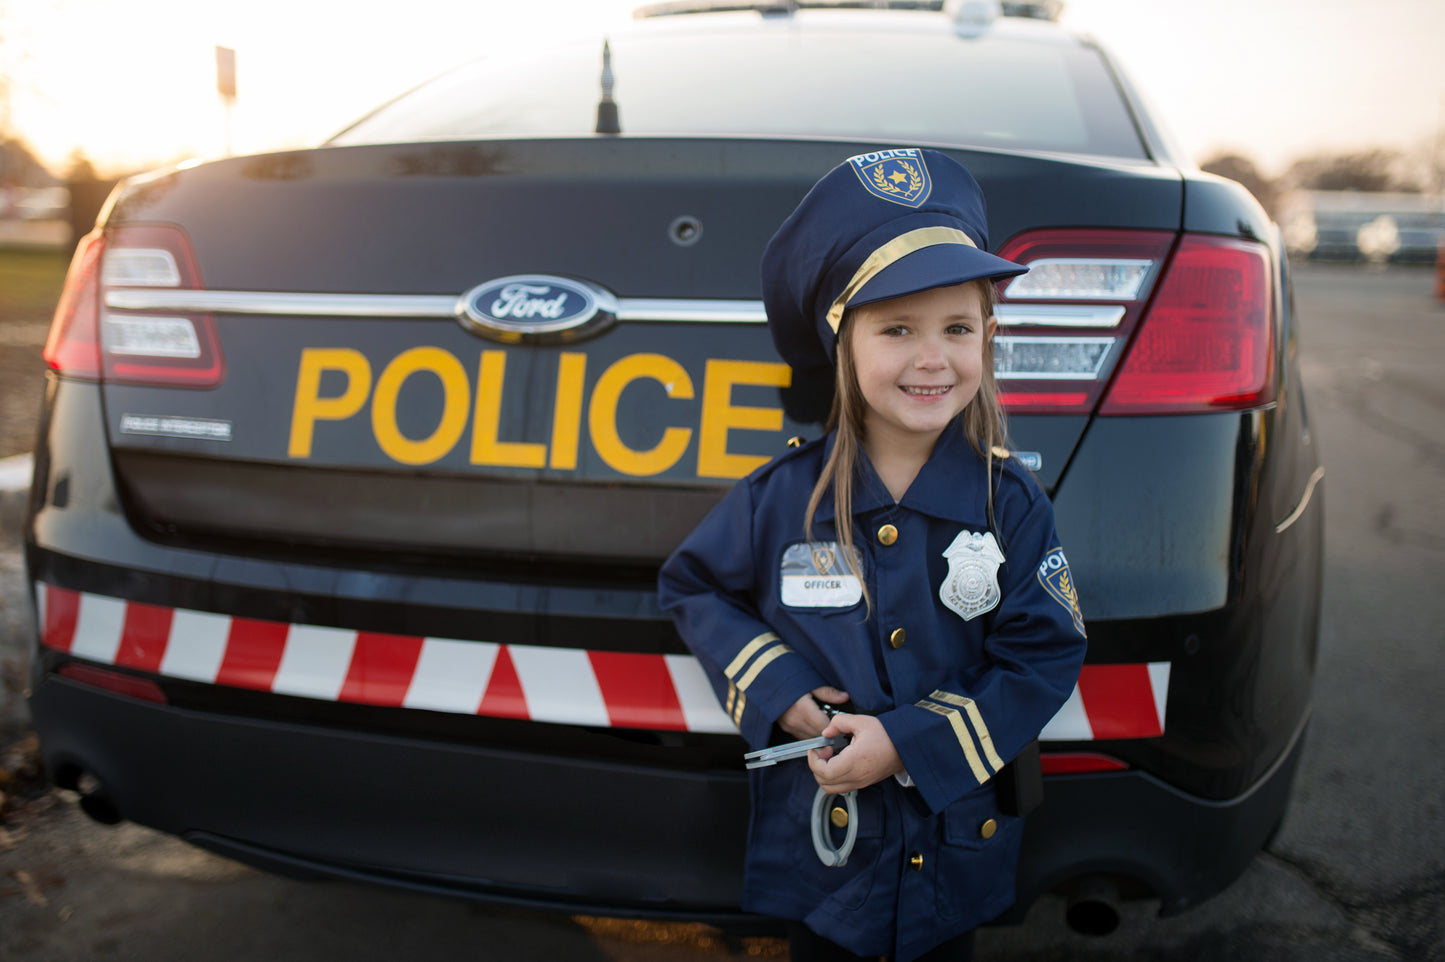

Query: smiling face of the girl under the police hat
848 282 996 454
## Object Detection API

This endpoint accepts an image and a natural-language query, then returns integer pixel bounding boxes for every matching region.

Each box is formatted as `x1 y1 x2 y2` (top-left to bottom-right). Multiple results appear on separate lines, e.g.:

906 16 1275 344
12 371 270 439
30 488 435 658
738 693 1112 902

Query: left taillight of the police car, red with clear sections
45 225 224 387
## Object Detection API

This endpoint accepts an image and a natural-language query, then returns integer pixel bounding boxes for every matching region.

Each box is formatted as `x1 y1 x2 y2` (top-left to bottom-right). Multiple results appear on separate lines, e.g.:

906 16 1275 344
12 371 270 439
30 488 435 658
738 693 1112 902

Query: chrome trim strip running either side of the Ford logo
105 289 767 324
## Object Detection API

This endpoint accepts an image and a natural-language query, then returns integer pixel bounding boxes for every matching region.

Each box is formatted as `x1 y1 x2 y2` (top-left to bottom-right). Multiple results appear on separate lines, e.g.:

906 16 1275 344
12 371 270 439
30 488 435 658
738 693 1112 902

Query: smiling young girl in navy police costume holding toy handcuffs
659 149 1085 961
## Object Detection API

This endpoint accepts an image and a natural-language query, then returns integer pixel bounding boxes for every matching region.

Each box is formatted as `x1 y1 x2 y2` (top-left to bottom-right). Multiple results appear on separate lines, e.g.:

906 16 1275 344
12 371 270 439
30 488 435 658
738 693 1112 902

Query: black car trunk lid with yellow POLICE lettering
103 137 1181 572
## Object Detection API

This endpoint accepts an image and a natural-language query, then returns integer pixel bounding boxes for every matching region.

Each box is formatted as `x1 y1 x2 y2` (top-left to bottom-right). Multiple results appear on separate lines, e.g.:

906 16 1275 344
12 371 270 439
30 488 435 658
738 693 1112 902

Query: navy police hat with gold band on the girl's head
763 147 1029 370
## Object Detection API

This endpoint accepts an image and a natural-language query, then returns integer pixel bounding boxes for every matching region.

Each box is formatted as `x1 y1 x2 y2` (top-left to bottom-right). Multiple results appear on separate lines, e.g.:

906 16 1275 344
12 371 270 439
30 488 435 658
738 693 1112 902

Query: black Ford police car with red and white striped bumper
26 3 1324 927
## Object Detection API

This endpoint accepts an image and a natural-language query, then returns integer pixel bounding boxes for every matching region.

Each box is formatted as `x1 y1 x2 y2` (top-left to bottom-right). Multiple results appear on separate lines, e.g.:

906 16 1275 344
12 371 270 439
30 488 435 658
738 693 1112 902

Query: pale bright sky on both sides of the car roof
0 0 1445 175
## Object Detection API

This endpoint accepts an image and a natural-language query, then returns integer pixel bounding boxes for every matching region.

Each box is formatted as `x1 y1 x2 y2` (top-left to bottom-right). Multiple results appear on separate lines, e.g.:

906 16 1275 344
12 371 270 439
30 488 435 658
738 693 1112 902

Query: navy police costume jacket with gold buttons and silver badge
659 420 1085 959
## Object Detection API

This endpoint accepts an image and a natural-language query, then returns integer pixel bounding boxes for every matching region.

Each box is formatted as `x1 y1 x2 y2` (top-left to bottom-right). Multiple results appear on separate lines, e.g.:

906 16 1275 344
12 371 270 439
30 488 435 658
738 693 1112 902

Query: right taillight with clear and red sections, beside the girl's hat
994 230 1274 415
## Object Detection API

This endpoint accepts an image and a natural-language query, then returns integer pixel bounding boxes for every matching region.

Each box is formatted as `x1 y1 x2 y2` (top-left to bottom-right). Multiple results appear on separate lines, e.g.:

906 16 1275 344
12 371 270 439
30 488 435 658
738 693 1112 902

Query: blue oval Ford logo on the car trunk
457 274 617 344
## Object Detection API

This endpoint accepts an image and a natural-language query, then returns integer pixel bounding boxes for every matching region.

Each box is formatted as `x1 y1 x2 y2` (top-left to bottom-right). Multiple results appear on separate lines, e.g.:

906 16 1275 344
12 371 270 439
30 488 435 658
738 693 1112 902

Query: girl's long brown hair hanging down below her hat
803 279 1009 610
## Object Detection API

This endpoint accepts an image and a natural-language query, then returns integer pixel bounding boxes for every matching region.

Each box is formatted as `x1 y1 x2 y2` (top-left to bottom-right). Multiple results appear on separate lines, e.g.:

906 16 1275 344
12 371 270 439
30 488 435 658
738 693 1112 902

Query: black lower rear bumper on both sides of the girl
30 664 1302 923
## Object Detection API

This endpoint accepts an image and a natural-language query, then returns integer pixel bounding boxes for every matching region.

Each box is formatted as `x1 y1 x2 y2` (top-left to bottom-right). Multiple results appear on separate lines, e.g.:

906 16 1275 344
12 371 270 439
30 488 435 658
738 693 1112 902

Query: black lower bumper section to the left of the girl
30 675 747 919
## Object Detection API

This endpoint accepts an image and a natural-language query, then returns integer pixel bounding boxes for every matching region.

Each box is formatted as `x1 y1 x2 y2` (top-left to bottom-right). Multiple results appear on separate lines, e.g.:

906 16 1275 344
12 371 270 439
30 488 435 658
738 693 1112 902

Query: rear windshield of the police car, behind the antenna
332 14 1147 159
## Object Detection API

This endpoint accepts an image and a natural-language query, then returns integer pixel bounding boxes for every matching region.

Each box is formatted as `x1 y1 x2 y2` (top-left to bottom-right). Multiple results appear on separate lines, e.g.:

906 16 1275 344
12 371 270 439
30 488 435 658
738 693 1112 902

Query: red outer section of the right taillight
1100 235 1274 415
